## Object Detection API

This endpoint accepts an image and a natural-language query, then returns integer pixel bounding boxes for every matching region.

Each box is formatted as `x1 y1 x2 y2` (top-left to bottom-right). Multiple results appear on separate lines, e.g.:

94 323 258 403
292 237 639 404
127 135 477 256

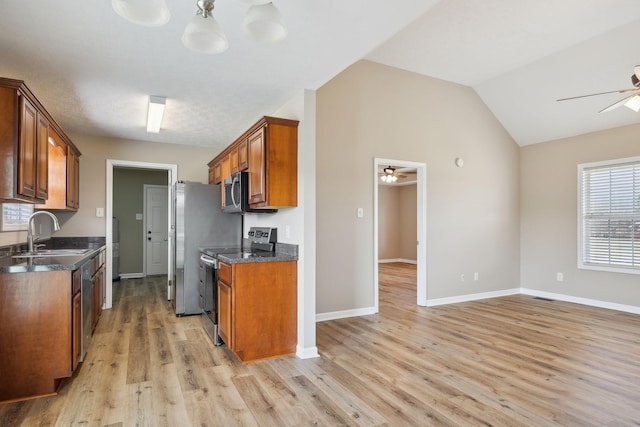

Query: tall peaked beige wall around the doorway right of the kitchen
316 61 520 313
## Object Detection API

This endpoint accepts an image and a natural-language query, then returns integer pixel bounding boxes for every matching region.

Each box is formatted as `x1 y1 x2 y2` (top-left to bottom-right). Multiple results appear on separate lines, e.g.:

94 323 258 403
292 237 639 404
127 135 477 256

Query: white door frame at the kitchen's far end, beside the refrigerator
104 159 178 308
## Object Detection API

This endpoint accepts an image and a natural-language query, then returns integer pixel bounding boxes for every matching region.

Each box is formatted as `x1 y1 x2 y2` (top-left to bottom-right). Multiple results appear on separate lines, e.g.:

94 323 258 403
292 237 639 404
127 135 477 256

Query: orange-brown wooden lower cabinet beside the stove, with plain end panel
218 261 297 362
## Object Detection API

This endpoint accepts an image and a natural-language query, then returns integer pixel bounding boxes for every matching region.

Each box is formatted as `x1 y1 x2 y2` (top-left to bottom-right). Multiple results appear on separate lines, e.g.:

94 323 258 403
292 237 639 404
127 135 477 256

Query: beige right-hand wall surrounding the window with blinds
520 125 640 306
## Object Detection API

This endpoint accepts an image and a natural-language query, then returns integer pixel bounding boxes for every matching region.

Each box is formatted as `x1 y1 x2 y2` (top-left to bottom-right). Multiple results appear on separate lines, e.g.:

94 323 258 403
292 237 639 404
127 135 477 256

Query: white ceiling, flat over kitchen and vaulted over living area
0 0 640 148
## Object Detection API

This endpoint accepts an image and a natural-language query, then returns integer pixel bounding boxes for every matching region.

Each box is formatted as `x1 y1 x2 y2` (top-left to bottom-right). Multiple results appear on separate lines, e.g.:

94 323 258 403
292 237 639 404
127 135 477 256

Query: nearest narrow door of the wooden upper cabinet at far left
17 96 38 197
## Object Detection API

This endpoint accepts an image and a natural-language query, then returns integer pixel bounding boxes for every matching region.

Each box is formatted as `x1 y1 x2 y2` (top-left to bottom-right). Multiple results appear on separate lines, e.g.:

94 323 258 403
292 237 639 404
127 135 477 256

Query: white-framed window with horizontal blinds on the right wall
578 157 640 274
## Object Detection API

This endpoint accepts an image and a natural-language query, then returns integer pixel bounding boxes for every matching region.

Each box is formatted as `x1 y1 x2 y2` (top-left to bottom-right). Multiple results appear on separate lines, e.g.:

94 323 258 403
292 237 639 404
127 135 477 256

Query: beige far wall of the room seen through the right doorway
378 184 418 261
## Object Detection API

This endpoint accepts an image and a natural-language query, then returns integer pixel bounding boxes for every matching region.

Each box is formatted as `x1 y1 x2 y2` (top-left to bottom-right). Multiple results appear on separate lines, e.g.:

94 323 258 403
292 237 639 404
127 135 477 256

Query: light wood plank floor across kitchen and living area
0 264 640 426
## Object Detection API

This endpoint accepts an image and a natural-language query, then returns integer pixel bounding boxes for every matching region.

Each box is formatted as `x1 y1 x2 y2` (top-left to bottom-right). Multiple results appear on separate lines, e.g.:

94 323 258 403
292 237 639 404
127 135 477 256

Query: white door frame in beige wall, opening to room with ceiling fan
373 158 427 312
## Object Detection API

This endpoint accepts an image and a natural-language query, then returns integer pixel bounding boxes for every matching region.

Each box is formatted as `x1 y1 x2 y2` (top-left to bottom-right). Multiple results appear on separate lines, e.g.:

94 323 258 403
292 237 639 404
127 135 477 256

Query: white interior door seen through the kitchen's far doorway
144 185 169 276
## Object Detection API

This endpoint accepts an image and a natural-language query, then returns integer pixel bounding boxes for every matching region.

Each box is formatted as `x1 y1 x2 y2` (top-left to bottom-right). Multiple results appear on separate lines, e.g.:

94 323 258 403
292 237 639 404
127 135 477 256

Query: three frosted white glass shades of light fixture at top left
111 0 287 54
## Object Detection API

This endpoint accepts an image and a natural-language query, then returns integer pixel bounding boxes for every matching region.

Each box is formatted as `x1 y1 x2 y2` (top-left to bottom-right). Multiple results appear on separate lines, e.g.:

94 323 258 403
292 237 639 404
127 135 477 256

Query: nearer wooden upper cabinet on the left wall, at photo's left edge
0 78 79 204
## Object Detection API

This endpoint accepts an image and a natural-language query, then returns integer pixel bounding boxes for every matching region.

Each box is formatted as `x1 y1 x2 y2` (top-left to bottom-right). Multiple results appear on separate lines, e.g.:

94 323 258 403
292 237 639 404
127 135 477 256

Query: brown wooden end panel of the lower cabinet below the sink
0 270 73 402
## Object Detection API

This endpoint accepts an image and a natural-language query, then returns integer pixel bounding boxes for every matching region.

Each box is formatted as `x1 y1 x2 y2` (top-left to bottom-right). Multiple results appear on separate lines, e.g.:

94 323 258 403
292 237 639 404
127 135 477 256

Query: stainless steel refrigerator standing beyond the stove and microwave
170 182 242 316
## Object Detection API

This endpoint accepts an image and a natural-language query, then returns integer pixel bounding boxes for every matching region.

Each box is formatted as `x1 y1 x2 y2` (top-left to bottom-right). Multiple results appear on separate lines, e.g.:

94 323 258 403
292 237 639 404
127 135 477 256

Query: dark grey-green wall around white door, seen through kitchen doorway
113 168 168 274
